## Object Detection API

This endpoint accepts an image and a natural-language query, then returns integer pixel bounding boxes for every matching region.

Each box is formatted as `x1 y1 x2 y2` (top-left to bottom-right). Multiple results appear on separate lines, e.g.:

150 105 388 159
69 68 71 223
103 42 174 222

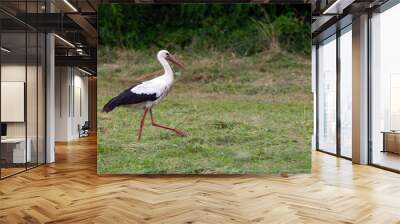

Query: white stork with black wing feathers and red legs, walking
102 50 186 141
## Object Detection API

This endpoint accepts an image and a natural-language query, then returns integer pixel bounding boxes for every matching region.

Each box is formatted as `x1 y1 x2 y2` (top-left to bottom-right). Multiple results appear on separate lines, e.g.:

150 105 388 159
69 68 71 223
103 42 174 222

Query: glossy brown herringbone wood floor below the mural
0 138 400 224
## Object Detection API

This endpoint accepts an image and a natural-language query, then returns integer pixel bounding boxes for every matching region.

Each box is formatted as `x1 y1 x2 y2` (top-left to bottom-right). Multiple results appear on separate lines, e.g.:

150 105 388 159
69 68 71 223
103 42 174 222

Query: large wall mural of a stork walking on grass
97 4 313 174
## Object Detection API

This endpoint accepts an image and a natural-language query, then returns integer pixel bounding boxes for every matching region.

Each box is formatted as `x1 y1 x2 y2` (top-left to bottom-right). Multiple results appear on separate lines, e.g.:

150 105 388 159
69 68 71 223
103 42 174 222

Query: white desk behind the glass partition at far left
1 138 32 163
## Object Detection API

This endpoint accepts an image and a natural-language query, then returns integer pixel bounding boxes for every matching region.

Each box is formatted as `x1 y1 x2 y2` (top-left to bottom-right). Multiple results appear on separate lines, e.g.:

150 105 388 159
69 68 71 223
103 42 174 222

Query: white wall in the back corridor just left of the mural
55 67 88 141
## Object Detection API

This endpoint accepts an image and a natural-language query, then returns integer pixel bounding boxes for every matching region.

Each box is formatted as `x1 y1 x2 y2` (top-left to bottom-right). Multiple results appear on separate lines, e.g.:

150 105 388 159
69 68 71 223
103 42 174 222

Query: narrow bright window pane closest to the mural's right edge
317 35 336 153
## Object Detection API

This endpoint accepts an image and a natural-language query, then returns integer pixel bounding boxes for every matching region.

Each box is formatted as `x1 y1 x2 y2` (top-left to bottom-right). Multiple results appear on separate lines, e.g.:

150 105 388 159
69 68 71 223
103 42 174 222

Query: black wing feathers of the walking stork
102 83 157 113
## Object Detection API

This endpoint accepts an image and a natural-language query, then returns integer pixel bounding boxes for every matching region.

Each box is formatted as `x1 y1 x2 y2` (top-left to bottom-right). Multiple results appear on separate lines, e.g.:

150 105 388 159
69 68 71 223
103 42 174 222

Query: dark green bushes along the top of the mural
98 4 311 56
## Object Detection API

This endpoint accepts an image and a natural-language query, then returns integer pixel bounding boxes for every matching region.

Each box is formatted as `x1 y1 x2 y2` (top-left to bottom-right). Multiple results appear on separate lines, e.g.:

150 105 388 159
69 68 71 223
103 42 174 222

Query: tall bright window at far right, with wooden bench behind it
370 1 400 170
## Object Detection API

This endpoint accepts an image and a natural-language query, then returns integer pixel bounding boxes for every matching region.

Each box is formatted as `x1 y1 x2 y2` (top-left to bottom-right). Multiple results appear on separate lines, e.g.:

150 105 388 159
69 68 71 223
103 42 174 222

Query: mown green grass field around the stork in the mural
97 49 313 174
